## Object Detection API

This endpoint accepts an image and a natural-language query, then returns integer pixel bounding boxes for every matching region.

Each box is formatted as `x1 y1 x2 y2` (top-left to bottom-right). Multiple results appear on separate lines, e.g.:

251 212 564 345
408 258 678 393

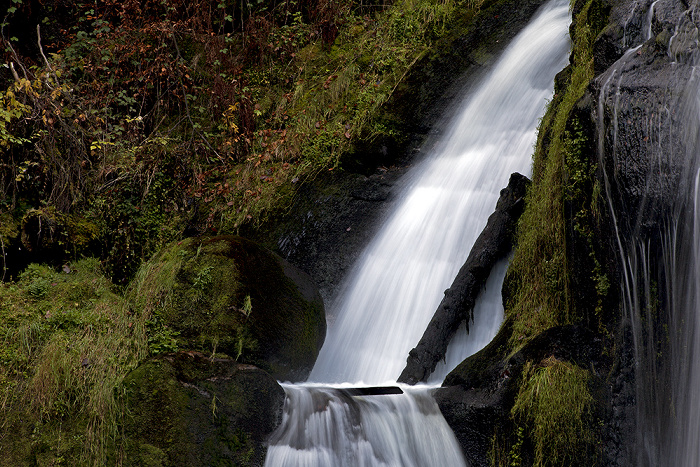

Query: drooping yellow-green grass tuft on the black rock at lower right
511 357 595 467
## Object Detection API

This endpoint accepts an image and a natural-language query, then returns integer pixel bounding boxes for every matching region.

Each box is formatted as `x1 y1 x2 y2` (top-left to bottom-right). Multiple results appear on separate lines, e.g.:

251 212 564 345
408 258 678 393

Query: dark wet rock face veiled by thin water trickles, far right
587 0 700 465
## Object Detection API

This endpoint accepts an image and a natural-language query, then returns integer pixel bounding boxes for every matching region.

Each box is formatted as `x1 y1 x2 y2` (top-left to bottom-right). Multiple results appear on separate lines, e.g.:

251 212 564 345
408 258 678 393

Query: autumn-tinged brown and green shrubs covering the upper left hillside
0 0 480 283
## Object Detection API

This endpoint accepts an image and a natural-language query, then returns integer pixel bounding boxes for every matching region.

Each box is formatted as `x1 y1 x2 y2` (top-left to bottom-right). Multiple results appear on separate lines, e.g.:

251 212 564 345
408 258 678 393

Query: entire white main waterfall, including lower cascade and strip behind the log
266 0 570 467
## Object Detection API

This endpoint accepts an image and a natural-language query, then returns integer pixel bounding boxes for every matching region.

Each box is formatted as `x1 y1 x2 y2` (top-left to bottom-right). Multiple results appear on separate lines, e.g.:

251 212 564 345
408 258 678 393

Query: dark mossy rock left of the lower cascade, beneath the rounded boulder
122 352 284 467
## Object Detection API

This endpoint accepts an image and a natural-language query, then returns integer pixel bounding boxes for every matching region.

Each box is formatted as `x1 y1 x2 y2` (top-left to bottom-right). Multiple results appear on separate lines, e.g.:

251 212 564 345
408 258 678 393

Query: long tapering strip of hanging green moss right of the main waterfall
506 0 605 348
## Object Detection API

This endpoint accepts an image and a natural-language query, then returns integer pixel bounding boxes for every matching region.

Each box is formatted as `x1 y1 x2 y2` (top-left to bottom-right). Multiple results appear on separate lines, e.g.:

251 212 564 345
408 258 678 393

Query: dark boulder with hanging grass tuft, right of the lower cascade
434 326 610 466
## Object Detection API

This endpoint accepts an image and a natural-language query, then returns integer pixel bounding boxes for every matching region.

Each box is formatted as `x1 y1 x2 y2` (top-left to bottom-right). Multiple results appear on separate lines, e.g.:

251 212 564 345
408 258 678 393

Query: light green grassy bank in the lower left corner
0 259 147 465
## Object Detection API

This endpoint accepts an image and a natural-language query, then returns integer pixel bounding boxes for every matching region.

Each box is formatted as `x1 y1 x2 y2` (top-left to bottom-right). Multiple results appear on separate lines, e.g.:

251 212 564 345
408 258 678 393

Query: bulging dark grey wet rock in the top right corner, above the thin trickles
590 1 698 245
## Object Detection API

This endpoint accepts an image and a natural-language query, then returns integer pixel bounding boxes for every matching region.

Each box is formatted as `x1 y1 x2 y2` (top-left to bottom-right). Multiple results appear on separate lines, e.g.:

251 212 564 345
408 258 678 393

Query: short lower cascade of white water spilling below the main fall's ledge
266 383 465 467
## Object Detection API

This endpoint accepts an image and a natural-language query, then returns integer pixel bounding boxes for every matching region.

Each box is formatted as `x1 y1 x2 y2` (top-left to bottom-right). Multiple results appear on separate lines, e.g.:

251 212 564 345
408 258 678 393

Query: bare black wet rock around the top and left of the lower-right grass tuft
434 326 609 466
